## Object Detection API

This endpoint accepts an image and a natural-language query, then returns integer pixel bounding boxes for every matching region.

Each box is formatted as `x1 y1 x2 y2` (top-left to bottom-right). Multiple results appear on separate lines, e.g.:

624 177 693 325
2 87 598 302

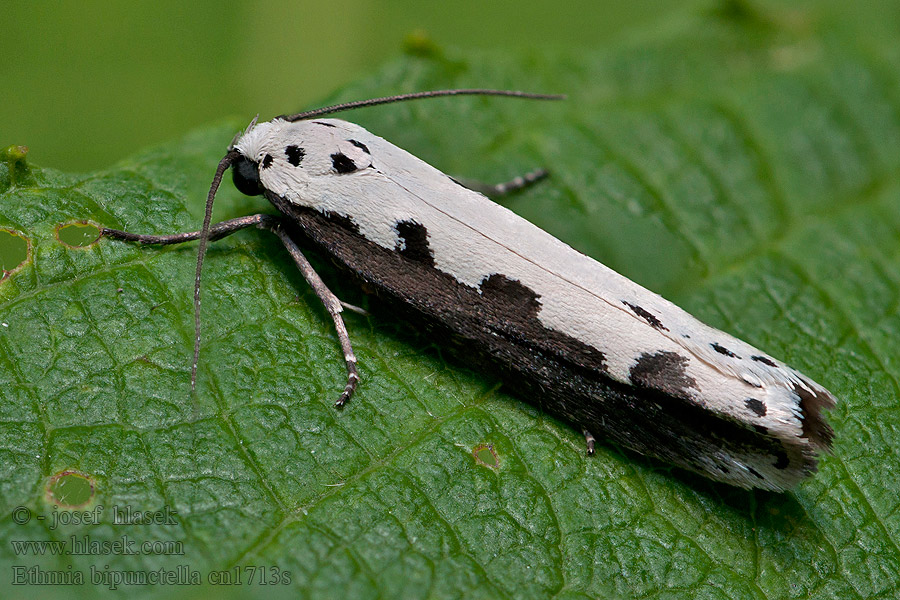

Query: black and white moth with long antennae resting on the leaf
102 90 835 490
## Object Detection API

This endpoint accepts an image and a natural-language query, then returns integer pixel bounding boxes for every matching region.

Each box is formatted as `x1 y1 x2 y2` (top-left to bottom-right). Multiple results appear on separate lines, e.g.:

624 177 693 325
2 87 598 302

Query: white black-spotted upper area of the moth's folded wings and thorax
250 119 834 489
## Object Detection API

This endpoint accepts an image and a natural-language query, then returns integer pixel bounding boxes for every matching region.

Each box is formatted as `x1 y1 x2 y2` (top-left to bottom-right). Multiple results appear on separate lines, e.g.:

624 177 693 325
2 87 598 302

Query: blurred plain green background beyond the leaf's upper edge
0 0 900 171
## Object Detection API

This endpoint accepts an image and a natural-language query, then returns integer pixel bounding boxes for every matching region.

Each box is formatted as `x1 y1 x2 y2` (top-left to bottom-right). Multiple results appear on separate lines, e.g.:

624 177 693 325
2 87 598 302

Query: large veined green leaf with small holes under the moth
0 8 900 598
